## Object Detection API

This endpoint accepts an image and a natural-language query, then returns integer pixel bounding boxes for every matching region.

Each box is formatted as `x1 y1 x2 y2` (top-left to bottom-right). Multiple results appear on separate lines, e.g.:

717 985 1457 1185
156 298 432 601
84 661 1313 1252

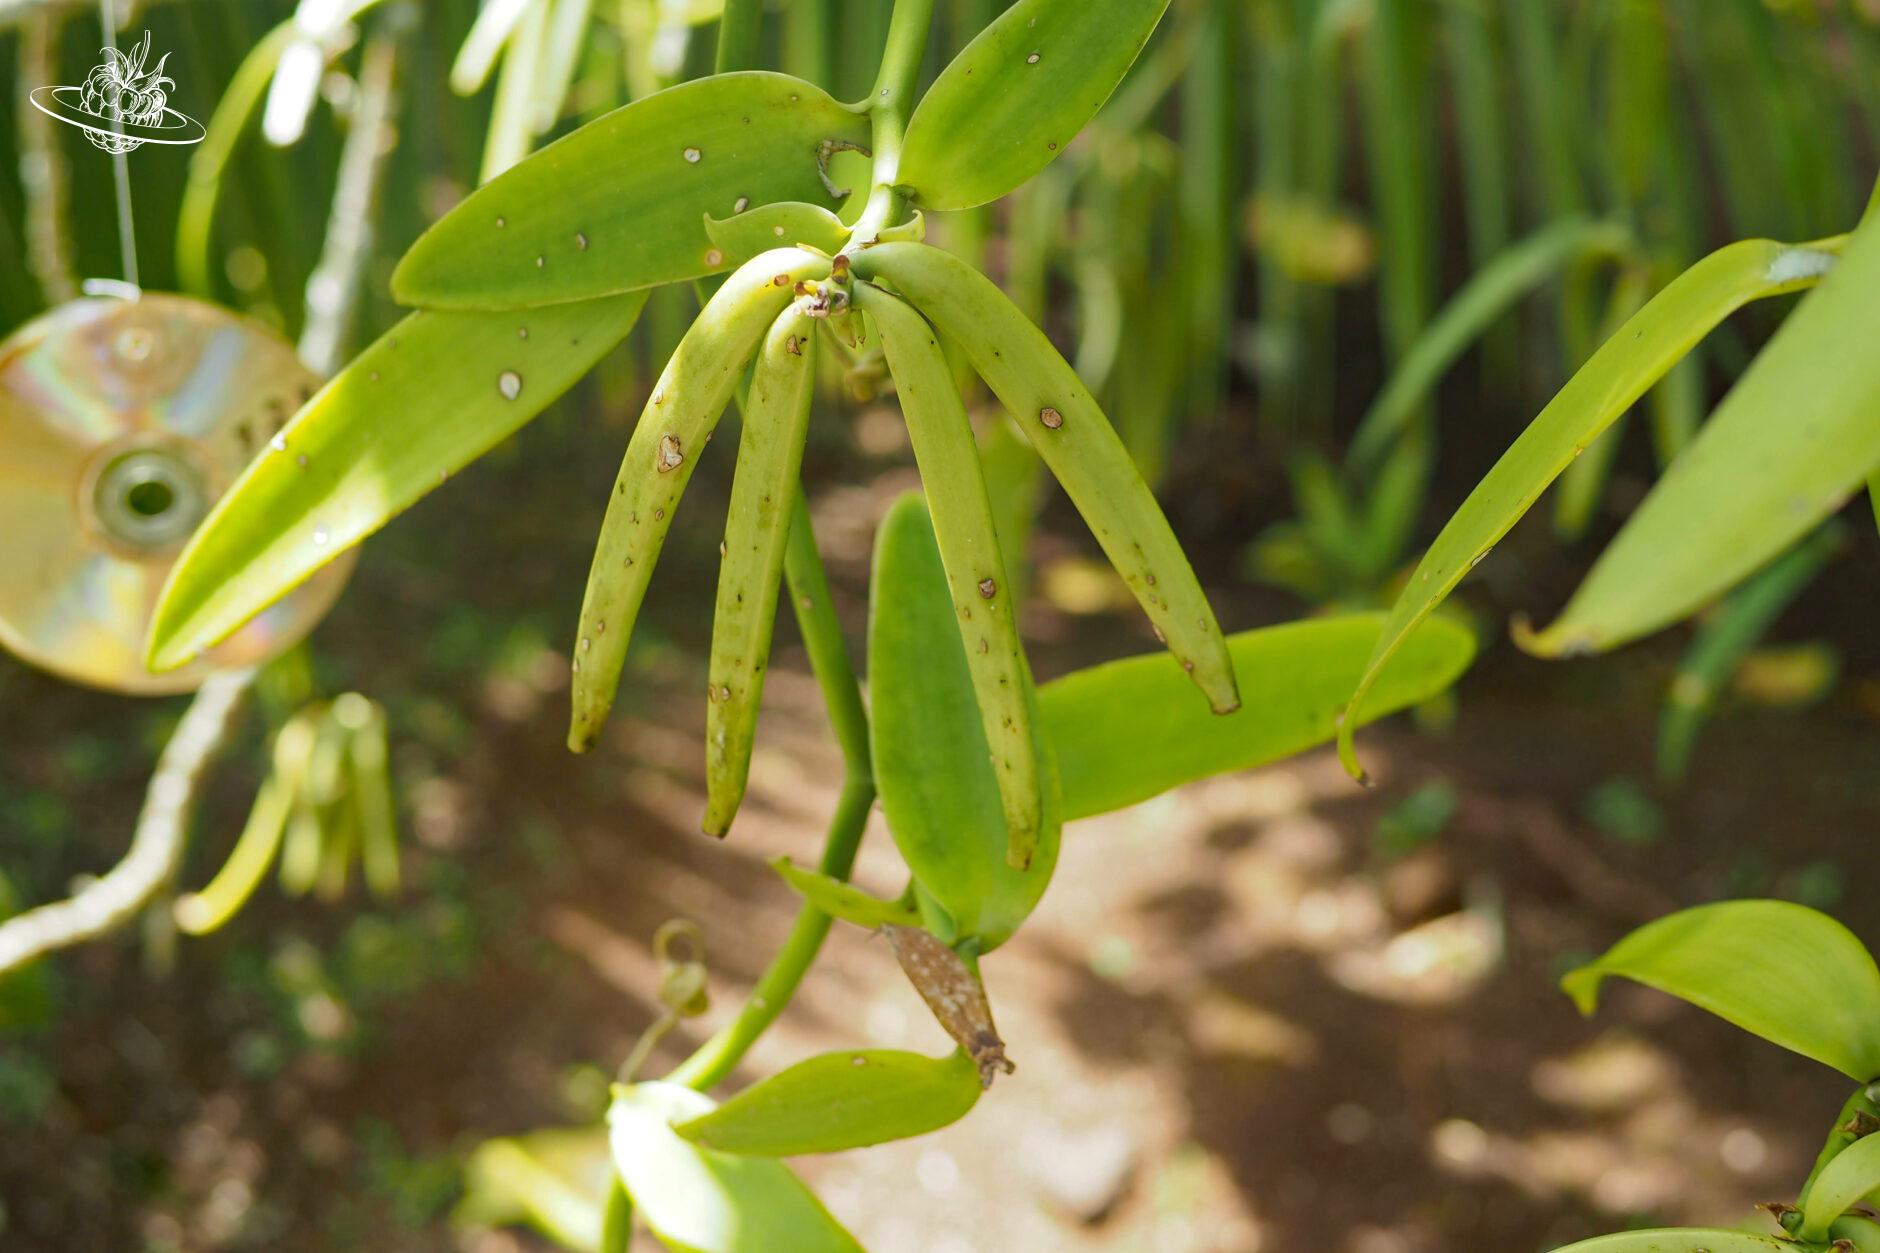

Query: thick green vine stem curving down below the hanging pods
667 487 874 1091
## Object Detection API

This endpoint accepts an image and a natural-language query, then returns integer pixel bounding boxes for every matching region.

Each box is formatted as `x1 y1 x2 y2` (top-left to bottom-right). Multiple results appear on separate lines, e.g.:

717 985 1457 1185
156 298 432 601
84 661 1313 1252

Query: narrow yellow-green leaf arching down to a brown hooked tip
1339 237 1844 777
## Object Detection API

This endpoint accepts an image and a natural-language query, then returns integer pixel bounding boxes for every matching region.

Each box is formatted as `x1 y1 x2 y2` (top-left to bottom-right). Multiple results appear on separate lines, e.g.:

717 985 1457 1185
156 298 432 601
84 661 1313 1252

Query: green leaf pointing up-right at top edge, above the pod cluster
897 0 1167 209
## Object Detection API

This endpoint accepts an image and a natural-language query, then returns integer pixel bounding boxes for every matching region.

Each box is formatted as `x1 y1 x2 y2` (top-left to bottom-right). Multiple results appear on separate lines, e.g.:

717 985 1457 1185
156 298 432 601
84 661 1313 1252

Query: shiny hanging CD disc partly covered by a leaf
0 293 353 694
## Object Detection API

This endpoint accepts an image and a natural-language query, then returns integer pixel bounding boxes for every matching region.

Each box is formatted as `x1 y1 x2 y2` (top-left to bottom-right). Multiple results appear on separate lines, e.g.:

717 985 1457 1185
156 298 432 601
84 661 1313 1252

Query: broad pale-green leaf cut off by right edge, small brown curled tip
1528 209 1880 655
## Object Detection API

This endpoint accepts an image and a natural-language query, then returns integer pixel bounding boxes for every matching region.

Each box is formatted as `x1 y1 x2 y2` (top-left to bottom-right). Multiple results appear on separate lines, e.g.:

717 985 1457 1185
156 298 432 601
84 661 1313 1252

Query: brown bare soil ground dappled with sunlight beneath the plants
0 408 1880 1253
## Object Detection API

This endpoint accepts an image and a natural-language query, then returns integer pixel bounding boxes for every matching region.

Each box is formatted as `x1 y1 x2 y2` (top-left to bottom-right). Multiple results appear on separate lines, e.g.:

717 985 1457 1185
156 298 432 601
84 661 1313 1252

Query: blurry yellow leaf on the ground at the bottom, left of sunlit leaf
451 1127 613 1253
